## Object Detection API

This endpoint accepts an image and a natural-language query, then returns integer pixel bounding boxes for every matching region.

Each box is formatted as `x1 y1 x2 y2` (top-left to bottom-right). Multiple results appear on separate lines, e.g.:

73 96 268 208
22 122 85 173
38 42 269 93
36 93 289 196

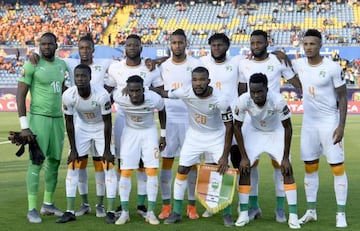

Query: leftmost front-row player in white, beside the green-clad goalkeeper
57 64 117 224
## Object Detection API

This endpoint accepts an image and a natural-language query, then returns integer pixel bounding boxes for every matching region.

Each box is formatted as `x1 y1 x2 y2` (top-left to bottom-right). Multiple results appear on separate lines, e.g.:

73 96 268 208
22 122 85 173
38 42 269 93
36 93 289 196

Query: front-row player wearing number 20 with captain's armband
153 67 234 226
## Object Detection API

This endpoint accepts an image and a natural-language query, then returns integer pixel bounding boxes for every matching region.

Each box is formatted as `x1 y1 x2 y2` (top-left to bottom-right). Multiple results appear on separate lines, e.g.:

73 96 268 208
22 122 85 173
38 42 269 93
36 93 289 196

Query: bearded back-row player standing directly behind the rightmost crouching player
233 30 301 223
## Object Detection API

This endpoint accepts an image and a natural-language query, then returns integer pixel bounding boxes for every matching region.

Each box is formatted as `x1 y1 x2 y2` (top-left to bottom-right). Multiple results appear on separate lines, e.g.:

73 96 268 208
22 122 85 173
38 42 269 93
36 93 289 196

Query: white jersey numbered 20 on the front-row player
168 86 232 133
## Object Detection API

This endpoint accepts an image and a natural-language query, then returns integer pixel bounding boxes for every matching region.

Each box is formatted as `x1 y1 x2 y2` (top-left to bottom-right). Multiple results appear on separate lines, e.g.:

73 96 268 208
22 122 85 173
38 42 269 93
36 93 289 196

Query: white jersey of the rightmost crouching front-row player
234 91 291 131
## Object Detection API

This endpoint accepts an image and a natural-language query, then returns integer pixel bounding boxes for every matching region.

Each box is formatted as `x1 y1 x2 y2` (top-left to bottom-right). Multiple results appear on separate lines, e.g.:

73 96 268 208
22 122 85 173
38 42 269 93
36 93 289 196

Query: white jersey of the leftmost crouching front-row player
62 84 111 126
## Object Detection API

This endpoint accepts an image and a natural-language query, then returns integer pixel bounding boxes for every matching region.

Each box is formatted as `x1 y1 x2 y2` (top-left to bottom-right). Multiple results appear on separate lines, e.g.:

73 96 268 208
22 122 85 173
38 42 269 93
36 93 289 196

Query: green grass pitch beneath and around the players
0 112 360 231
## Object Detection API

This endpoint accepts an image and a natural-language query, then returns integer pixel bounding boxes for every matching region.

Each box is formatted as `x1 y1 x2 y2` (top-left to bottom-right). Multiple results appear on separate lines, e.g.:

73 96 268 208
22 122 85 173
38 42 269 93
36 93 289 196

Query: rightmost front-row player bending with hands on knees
234 73 301 229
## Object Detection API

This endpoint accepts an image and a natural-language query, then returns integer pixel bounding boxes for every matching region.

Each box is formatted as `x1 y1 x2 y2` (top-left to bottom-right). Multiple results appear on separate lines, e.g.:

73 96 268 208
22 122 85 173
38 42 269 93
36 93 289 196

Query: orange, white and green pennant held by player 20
195 164 237 213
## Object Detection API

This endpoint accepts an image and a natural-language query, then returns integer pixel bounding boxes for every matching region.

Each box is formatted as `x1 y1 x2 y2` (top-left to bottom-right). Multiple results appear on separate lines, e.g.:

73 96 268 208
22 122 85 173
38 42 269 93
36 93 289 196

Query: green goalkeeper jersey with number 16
18 58 67 117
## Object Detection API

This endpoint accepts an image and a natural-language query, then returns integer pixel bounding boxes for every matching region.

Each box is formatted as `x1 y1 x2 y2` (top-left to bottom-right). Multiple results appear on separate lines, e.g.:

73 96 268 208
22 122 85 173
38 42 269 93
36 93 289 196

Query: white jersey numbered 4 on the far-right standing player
293 57 345 124
